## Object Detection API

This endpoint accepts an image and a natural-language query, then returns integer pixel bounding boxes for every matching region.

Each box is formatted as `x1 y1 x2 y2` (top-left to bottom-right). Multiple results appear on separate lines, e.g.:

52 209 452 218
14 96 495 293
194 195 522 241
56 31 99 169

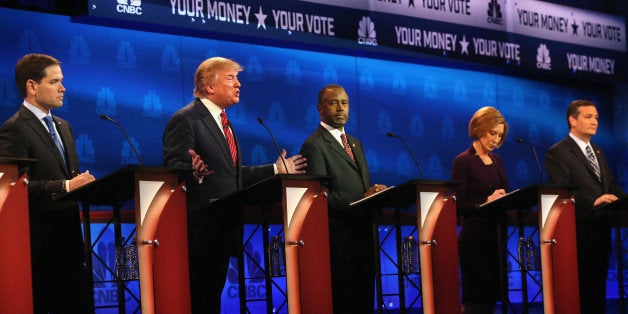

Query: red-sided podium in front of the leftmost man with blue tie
65 165 192 313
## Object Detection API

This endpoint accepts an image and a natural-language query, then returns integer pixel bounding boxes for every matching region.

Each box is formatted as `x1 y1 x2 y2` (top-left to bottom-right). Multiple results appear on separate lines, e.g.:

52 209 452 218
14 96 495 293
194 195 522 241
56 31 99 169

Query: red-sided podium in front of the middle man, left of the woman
351 180 461 313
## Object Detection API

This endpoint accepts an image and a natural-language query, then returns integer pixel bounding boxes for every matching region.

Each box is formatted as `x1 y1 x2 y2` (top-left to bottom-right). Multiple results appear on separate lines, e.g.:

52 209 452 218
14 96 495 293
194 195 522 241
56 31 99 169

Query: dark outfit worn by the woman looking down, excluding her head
451 145 508 303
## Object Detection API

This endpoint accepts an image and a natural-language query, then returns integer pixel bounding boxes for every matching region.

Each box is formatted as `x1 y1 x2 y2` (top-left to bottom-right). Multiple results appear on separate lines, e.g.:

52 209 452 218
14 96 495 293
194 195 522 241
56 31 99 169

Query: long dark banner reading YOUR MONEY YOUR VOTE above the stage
89 0 627 81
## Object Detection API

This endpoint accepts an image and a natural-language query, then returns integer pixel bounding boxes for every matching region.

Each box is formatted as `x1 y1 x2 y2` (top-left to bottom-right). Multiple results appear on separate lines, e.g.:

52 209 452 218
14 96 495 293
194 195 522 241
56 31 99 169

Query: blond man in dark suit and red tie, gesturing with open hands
163 57 306 314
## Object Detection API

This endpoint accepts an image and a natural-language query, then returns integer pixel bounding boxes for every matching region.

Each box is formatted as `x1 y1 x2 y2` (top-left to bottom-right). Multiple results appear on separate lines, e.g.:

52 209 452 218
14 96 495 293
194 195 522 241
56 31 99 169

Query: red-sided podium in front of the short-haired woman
480 184 580 313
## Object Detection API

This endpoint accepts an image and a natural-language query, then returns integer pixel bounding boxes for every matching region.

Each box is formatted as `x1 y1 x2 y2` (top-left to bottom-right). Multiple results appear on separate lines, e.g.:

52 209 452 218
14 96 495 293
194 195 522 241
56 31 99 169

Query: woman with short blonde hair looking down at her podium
451 107 508 314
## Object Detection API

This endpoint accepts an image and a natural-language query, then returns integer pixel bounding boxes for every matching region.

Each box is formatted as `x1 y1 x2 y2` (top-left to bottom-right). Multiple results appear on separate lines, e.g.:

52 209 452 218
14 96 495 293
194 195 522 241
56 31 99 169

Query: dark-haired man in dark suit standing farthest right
545 100 624 314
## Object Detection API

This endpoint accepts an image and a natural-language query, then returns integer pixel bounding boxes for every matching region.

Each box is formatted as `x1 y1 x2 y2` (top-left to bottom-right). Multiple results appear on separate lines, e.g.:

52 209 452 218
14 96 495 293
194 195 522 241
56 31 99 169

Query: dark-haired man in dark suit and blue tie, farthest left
0 54 94 313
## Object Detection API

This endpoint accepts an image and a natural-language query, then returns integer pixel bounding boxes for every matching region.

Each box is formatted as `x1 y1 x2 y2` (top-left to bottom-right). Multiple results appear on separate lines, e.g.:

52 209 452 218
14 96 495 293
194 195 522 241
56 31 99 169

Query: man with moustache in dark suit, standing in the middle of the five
301 84 386 313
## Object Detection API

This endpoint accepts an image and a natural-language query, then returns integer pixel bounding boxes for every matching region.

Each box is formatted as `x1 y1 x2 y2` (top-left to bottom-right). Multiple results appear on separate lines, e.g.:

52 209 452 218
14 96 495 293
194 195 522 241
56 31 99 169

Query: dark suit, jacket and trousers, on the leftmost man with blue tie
0 106 93 313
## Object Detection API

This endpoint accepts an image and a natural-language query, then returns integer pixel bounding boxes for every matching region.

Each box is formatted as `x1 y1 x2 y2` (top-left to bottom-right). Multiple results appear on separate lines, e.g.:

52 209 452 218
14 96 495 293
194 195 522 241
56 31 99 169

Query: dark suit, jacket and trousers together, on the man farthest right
545 136 623 314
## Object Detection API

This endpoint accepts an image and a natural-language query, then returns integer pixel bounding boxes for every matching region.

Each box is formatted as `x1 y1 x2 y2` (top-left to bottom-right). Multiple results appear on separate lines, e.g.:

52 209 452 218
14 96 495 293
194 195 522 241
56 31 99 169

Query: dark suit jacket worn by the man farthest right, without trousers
545 136 623 219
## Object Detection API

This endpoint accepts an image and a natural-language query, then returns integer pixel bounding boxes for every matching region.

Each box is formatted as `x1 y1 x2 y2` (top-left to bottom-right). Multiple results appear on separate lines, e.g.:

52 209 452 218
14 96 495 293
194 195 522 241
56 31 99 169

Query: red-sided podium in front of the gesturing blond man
210 174 332 314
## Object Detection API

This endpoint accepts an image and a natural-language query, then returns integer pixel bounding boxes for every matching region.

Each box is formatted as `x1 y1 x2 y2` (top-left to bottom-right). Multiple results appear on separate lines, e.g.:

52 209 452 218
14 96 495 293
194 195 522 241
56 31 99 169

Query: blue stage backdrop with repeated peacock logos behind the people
0 8 628 314
